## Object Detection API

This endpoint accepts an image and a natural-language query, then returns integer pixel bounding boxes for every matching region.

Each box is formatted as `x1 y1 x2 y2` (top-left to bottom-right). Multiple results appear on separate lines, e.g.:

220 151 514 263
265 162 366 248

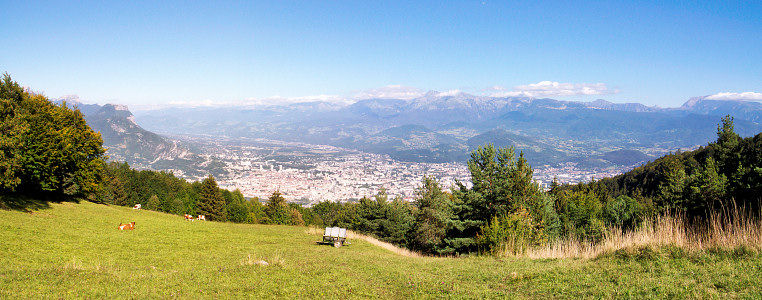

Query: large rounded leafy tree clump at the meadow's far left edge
0 74 105 196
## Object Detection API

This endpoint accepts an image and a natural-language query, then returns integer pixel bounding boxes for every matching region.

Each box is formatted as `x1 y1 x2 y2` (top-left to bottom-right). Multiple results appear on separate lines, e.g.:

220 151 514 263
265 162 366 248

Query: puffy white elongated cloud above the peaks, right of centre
485 81 619 98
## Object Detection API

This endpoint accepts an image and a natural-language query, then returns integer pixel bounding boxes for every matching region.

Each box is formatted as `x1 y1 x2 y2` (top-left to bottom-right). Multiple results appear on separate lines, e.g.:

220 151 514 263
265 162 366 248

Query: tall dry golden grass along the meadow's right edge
524 208 762 259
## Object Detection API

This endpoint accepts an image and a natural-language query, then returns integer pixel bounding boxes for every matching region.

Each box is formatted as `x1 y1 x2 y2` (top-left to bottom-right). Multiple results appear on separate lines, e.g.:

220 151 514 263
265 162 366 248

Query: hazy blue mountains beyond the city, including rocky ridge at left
58 92 762 174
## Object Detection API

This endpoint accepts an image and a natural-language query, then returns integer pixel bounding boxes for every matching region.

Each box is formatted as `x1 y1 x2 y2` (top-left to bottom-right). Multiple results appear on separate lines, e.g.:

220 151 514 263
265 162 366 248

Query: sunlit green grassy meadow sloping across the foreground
0 202 762 299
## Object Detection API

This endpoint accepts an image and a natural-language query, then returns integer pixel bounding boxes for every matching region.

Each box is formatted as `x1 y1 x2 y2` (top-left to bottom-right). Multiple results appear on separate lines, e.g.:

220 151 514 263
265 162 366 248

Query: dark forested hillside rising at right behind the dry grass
576 116 762 219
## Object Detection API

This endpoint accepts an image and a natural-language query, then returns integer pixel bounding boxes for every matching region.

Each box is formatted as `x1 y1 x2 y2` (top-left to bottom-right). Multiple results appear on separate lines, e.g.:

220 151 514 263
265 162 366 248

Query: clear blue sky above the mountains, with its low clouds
0 0 762 109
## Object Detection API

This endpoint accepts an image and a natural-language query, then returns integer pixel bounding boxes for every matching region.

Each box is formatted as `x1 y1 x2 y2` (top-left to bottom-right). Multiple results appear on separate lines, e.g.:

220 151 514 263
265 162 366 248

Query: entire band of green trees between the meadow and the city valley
0 74 762 255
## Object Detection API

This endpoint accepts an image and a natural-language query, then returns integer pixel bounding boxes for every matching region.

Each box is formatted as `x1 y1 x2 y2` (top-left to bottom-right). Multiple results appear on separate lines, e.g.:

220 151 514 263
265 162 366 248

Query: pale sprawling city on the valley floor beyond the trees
175 136 631 205
